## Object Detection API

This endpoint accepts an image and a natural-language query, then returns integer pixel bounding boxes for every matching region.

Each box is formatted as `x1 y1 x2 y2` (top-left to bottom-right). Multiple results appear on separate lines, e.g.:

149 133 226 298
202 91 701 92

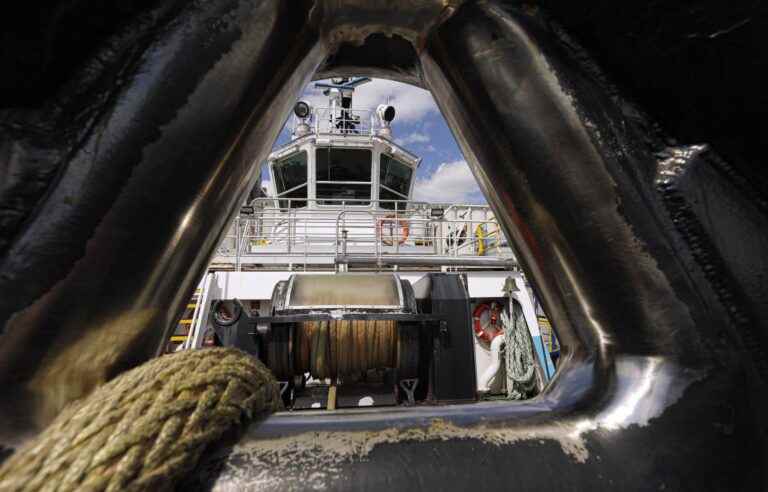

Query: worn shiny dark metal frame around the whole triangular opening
0 0 765 490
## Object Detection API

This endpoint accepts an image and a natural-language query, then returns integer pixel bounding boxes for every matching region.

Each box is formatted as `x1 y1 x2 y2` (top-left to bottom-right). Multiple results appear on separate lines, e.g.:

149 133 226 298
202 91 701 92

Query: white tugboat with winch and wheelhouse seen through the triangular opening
167 78 557 410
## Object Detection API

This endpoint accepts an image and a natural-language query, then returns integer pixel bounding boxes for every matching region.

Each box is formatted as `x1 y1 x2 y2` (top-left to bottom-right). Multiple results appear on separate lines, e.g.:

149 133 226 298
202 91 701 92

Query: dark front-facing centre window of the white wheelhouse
315 147 371 205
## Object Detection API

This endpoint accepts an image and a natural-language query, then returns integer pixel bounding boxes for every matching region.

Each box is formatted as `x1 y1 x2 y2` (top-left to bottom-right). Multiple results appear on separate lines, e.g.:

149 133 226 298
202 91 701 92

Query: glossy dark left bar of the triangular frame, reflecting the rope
0 0 327 441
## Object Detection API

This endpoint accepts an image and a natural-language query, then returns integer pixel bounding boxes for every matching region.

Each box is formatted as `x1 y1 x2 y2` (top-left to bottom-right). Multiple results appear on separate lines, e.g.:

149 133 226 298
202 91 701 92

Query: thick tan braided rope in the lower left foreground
0 348 280 491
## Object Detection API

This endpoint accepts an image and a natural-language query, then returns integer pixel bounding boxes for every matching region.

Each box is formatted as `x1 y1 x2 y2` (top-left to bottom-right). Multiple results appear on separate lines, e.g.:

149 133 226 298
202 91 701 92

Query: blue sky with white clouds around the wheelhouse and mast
262 79 485 204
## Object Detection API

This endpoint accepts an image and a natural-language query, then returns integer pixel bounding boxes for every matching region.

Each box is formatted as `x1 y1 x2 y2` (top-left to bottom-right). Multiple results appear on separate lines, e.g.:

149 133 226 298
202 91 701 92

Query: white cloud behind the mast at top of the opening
301 79 440 122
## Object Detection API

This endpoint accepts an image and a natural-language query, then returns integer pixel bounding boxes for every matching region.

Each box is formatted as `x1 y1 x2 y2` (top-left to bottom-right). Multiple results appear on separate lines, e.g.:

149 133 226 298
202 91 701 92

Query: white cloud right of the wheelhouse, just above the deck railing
414 160 484 203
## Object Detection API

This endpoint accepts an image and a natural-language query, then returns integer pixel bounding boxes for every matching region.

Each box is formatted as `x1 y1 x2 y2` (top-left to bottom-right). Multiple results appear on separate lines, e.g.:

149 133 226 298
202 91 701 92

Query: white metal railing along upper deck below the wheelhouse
214 198 513 270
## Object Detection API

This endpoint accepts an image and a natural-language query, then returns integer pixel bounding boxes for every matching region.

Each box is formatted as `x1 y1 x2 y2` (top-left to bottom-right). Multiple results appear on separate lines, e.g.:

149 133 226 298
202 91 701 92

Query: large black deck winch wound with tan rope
211 273 476 409
